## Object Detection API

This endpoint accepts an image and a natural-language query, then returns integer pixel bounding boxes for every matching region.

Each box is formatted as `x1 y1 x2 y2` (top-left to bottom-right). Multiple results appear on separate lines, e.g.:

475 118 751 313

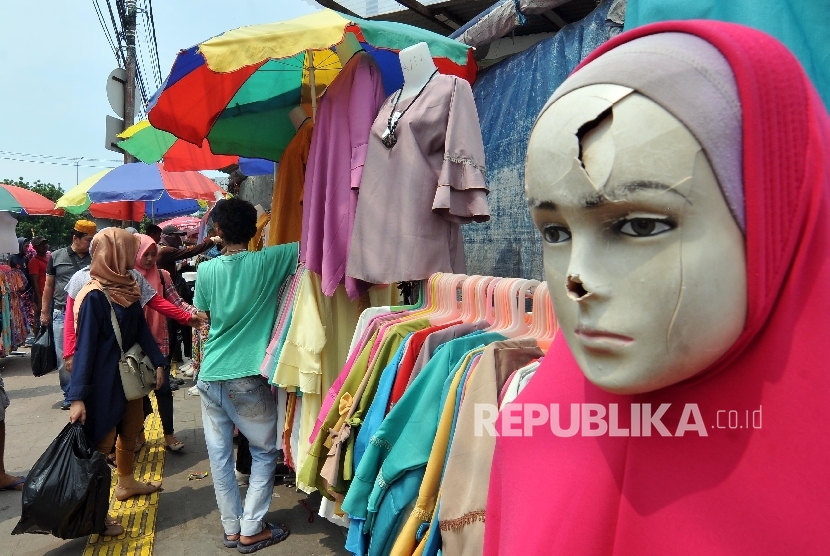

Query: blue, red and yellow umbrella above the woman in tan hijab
55 162 224 220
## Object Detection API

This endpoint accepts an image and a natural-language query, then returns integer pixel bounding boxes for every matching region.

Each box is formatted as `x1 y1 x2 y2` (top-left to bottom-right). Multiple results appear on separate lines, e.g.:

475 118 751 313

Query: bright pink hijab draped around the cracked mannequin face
484 21 830 556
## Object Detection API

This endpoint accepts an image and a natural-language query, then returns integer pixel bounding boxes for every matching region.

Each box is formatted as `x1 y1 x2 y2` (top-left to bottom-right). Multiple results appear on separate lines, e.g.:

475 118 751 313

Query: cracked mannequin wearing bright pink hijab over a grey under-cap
484 21 830 556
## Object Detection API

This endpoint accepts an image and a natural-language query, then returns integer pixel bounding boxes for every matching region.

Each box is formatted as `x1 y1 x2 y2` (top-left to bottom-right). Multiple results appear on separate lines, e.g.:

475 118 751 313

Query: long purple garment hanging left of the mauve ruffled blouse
300 52 385 299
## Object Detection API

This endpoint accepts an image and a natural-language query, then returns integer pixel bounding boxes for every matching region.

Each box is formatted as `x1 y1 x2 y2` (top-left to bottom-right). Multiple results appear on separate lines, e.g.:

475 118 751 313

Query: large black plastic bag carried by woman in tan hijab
12 422 112 539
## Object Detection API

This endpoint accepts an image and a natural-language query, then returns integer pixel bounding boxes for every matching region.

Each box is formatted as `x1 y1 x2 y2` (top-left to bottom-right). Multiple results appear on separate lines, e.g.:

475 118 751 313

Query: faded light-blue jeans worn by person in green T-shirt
196 375 277 536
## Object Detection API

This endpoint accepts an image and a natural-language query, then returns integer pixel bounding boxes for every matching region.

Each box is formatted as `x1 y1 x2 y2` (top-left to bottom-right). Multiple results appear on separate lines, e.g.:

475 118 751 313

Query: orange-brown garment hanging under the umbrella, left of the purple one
268 118 314 245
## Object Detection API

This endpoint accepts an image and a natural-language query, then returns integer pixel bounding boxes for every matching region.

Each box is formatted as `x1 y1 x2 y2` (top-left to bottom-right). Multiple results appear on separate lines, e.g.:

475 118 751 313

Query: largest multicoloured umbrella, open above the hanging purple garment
149 9 476 161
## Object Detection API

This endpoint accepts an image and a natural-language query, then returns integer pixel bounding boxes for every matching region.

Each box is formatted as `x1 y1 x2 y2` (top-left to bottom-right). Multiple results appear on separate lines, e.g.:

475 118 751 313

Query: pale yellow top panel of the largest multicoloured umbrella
199 10 350 73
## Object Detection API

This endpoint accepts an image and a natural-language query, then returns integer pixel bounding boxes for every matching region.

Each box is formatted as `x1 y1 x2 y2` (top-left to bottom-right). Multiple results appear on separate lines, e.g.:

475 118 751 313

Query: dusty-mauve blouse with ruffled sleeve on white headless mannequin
346 74 490 284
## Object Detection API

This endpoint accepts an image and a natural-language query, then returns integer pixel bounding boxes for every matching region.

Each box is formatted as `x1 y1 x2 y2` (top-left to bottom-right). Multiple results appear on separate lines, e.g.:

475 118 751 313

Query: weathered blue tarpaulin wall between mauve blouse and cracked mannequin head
462 0 625 280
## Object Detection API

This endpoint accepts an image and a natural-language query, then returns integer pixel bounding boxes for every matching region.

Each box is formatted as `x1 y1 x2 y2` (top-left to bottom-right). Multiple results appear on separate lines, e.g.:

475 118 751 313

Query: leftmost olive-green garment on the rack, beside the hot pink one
297 319 429 497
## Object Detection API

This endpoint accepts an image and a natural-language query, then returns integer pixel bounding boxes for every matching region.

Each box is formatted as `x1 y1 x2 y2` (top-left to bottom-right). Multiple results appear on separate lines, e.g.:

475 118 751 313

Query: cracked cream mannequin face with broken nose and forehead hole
525 85 747 394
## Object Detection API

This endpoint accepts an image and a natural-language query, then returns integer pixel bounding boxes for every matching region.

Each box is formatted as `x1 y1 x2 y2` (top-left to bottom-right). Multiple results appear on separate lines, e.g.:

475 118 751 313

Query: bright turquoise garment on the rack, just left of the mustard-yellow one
342 332 505 552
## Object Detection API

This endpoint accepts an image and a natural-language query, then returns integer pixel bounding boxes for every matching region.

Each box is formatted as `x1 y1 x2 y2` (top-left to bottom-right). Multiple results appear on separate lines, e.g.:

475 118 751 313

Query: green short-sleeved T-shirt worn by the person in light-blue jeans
193 243 299 381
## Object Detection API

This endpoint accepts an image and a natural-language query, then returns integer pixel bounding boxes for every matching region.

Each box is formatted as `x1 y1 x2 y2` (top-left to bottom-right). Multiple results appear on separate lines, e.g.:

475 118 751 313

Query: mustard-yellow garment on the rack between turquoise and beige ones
389 347 484 556
